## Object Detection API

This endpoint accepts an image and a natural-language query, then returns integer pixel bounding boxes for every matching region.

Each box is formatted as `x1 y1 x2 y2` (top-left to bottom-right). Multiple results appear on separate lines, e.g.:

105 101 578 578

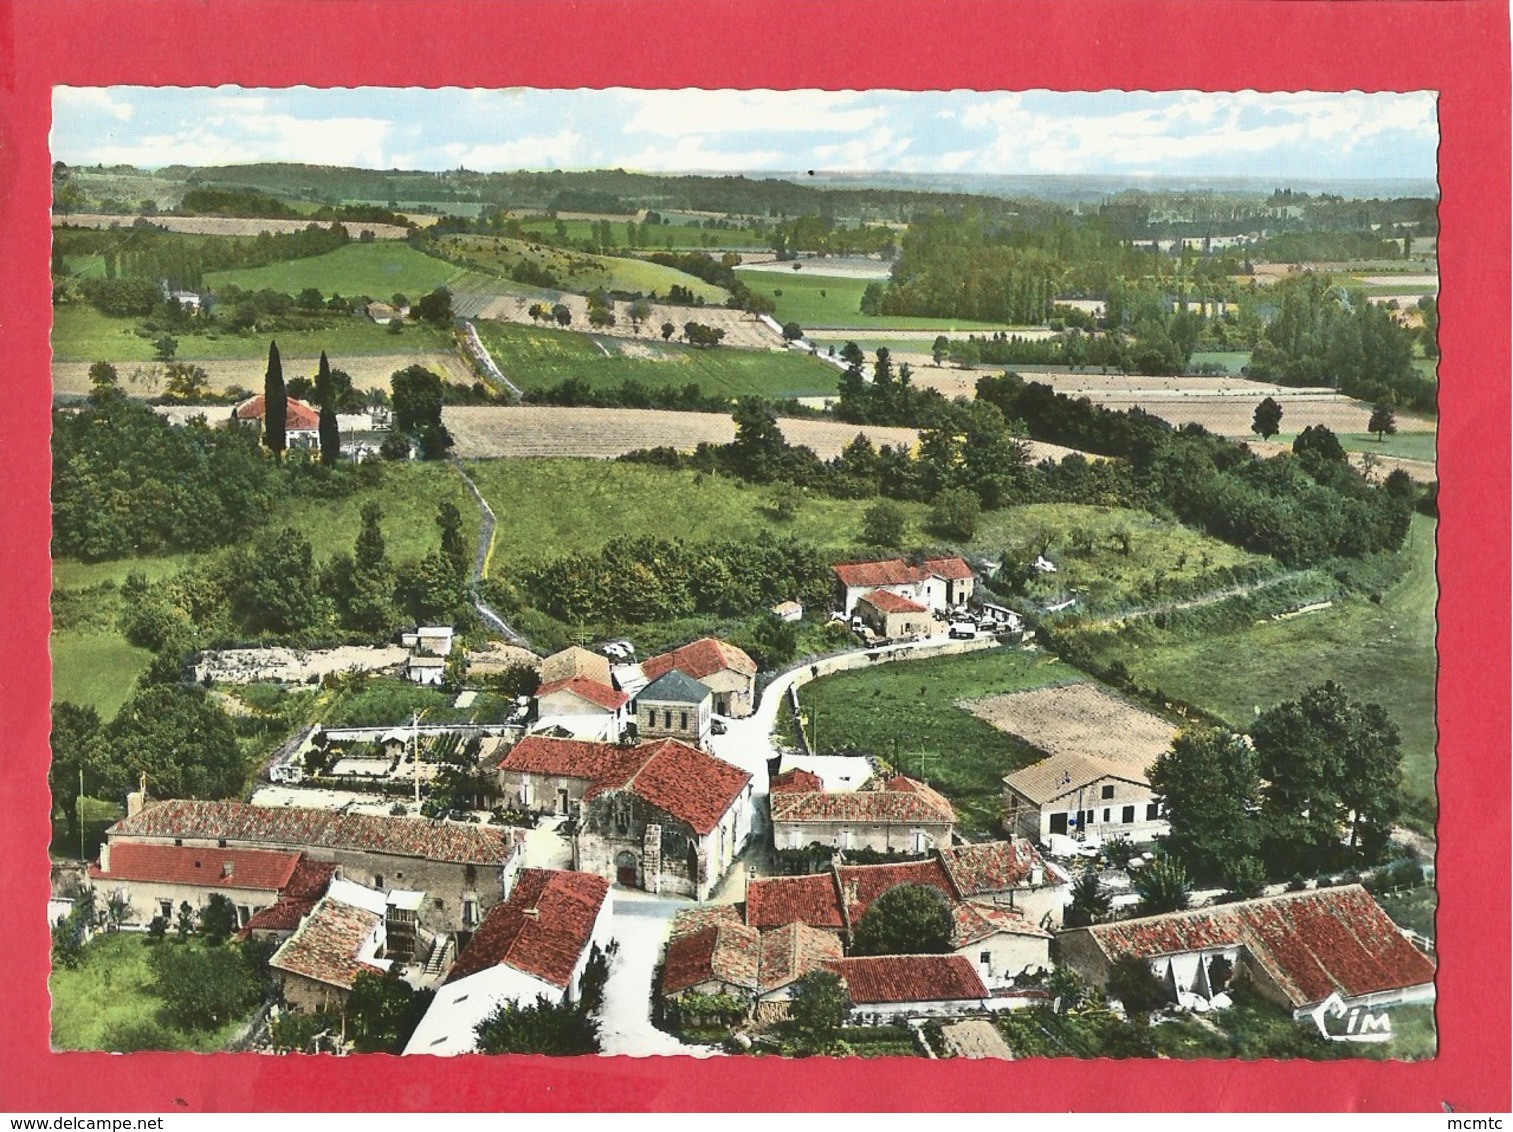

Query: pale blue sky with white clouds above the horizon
53 86 1439 180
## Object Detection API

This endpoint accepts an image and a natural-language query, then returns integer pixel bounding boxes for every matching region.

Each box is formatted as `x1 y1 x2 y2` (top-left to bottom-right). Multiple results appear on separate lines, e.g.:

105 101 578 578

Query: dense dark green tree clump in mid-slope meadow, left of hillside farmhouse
517 531 831 625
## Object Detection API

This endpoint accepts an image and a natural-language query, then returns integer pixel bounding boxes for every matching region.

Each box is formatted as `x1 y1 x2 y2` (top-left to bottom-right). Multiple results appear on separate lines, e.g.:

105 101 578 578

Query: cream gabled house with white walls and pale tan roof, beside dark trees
1003 752 1170 844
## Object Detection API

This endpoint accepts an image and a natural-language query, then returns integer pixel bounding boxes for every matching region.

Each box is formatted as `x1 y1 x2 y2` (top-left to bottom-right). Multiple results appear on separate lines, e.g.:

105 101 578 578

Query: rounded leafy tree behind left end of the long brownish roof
100 684 247 798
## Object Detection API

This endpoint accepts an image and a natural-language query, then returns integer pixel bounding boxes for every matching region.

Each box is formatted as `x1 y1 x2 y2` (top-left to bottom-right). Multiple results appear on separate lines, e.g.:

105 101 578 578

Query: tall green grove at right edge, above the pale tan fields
1248 272 1436 413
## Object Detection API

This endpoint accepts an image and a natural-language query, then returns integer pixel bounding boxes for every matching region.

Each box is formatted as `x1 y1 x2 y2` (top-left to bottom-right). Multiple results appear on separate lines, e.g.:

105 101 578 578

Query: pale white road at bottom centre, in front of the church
599 888 720 1058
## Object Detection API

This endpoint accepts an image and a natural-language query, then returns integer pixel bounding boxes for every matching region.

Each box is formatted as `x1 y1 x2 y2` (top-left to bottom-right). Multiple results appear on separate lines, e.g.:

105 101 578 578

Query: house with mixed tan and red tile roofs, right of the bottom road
661 905 841 1025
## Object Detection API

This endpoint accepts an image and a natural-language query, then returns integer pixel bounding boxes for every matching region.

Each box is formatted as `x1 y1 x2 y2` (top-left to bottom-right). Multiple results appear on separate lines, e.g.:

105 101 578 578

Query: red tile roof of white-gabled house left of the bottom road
446 869 610 988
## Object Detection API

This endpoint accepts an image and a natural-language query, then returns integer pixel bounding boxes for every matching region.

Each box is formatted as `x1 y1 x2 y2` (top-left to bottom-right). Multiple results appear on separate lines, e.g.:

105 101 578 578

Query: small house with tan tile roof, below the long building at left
268 881 390 1014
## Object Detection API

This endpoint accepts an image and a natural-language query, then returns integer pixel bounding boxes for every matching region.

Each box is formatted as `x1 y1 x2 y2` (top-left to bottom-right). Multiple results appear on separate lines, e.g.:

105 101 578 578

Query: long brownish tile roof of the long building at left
106 799 514 866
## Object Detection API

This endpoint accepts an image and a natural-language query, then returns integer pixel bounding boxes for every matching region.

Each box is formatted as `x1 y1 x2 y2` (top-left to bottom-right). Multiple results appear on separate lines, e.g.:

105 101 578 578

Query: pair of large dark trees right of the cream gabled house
1151 681 1403 894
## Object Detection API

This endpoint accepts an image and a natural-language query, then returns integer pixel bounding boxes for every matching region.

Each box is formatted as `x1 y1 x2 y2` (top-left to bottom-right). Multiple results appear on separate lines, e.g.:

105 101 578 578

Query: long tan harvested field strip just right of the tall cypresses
442 406 917 460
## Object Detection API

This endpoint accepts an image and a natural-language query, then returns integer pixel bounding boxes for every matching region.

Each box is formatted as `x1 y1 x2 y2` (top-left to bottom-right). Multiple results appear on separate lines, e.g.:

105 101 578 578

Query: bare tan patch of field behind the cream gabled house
959 684 1177 770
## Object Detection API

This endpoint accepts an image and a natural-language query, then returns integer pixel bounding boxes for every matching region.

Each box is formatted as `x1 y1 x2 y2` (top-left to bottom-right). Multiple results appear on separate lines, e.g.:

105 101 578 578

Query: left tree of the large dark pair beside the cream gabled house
1150 729 1260 881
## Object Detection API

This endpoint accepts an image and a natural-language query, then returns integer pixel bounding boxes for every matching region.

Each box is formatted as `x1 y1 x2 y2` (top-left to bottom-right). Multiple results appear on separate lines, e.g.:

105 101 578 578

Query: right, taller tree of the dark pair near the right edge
1251 681 1403 872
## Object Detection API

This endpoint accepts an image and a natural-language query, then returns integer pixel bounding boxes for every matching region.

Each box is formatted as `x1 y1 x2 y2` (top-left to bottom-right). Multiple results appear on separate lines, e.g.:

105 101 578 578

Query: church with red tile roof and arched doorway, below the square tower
495 735 752 900
